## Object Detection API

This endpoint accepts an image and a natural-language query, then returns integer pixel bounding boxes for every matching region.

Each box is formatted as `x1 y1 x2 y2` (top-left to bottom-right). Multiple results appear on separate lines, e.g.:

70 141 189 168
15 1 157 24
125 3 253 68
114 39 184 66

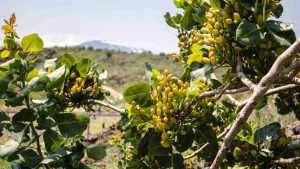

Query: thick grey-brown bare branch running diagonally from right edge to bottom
210 40 300 169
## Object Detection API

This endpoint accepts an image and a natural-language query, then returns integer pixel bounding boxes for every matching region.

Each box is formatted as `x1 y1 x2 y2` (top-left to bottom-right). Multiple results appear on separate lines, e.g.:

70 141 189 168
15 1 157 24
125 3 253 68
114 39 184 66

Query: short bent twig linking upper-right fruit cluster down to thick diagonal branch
236 56 256 92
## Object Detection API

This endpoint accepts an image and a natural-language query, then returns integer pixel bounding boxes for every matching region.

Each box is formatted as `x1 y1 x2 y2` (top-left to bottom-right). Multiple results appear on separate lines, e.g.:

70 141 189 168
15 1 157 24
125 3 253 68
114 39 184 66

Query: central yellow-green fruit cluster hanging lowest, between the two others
150 70 190 147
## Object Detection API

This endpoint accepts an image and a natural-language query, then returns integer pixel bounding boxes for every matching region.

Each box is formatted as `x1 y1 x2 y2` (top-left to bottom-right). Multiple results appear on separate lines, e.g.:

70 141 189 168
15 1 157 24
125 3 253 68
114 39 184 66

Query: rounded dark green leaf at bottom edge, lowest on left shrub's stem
18 149 43 168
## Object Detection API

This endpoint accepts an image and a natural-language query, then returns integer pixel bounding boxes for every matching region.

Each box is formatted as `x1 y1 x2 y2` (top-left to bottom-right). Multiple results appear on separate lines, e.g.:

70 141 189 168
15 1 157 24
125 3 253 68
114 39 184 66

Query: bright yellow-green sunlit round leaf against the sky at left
21 34 44 52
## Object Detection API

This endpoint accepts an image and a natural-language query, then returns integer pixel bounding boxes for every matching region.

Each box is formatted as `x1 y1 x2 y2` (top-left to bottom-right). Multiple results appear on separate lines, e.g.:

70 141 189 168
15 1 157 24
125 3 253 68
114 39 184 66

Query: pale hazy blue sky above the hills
0 0 300 52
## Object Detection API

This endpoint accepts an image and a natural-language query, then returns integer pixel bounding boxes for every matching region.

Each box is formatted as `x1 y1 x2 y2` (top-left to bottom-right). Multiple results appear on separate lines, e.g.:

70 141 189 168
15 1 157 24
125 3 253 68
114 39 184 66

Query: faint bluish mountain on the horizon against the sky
79 40 148 53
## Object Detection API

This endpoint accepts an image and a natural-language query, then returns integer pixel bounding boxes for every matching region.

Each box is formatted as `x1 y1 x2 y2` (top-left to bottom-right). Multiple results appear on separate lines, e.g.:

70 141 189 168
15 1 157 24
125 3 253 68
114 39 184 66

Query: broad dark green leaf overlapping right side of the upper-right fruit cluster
236 21 264 45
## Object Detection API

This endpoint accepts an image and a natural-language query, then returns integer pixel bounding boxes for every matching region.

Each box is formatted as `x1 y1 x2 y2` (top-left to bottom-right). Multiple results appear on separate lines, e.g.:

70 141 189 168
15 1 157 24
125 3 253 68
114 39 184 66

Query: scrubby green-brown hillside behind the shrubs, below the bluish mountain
38 47 183 93
